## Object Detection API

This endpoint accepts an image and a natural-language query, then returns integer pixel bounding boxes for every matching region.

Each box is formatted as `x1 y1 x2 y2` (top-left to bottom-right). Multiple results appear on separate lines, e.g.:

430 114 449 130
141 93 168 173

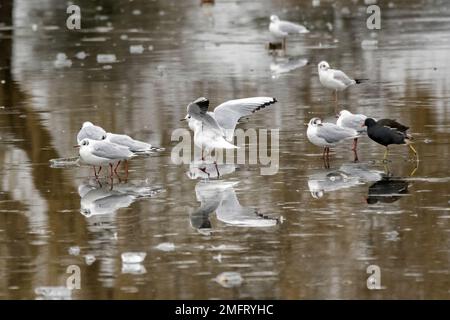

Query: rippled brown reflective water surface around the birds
0 0 450 299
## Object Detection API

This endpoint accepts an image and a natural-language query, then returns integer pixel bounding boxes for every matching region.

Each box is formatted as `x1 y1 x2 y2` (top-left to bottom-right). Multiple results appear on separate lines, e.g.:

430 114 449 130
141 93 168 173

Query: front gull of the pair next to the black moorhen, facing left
306 118 358 159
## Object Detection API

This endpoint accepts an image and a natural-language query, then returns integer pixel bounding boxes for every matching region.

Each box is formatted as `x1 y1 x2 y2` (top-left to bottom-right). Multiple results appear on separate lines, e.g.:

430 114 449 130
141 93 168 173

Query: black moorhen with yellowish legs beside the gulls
364 118 418 160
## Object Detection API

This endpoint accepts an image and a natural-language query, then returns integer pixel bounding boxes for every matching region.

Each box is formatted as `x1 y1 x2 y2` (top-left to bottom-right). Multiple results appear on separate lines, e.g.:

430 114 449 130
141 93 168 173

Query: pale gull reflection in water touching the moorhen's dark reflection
308 163 385 199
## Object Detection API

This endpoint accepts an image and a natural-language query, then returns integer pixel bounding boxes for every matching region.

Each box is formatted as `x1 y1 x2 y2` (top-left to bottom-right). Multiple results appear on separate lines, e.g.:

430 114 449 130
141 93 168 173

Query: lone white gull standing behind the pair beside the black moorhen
317 61 367 112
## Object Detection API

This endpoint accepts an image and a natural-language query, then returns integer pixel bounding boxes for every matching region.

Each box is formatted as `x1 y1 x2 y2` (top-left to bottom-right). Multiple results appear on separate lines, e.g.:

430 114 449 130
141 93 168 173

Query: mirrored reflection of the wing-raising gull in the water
190 181 280 231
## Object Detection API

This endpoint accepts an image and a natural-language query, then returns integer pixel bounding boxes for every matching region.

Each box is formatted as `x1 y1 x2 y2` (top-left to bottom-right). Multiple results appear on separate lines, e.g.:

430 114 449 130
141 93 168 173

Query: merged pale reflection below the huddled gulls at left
78 180 163 217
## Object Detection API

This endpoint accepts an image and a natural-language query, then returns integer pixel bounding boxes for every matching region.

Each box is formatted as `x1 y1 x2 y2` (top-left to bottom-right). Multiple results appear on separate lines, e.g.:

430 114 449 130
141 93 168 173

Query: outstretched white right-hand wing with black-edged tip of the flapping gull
214 97 277 141
